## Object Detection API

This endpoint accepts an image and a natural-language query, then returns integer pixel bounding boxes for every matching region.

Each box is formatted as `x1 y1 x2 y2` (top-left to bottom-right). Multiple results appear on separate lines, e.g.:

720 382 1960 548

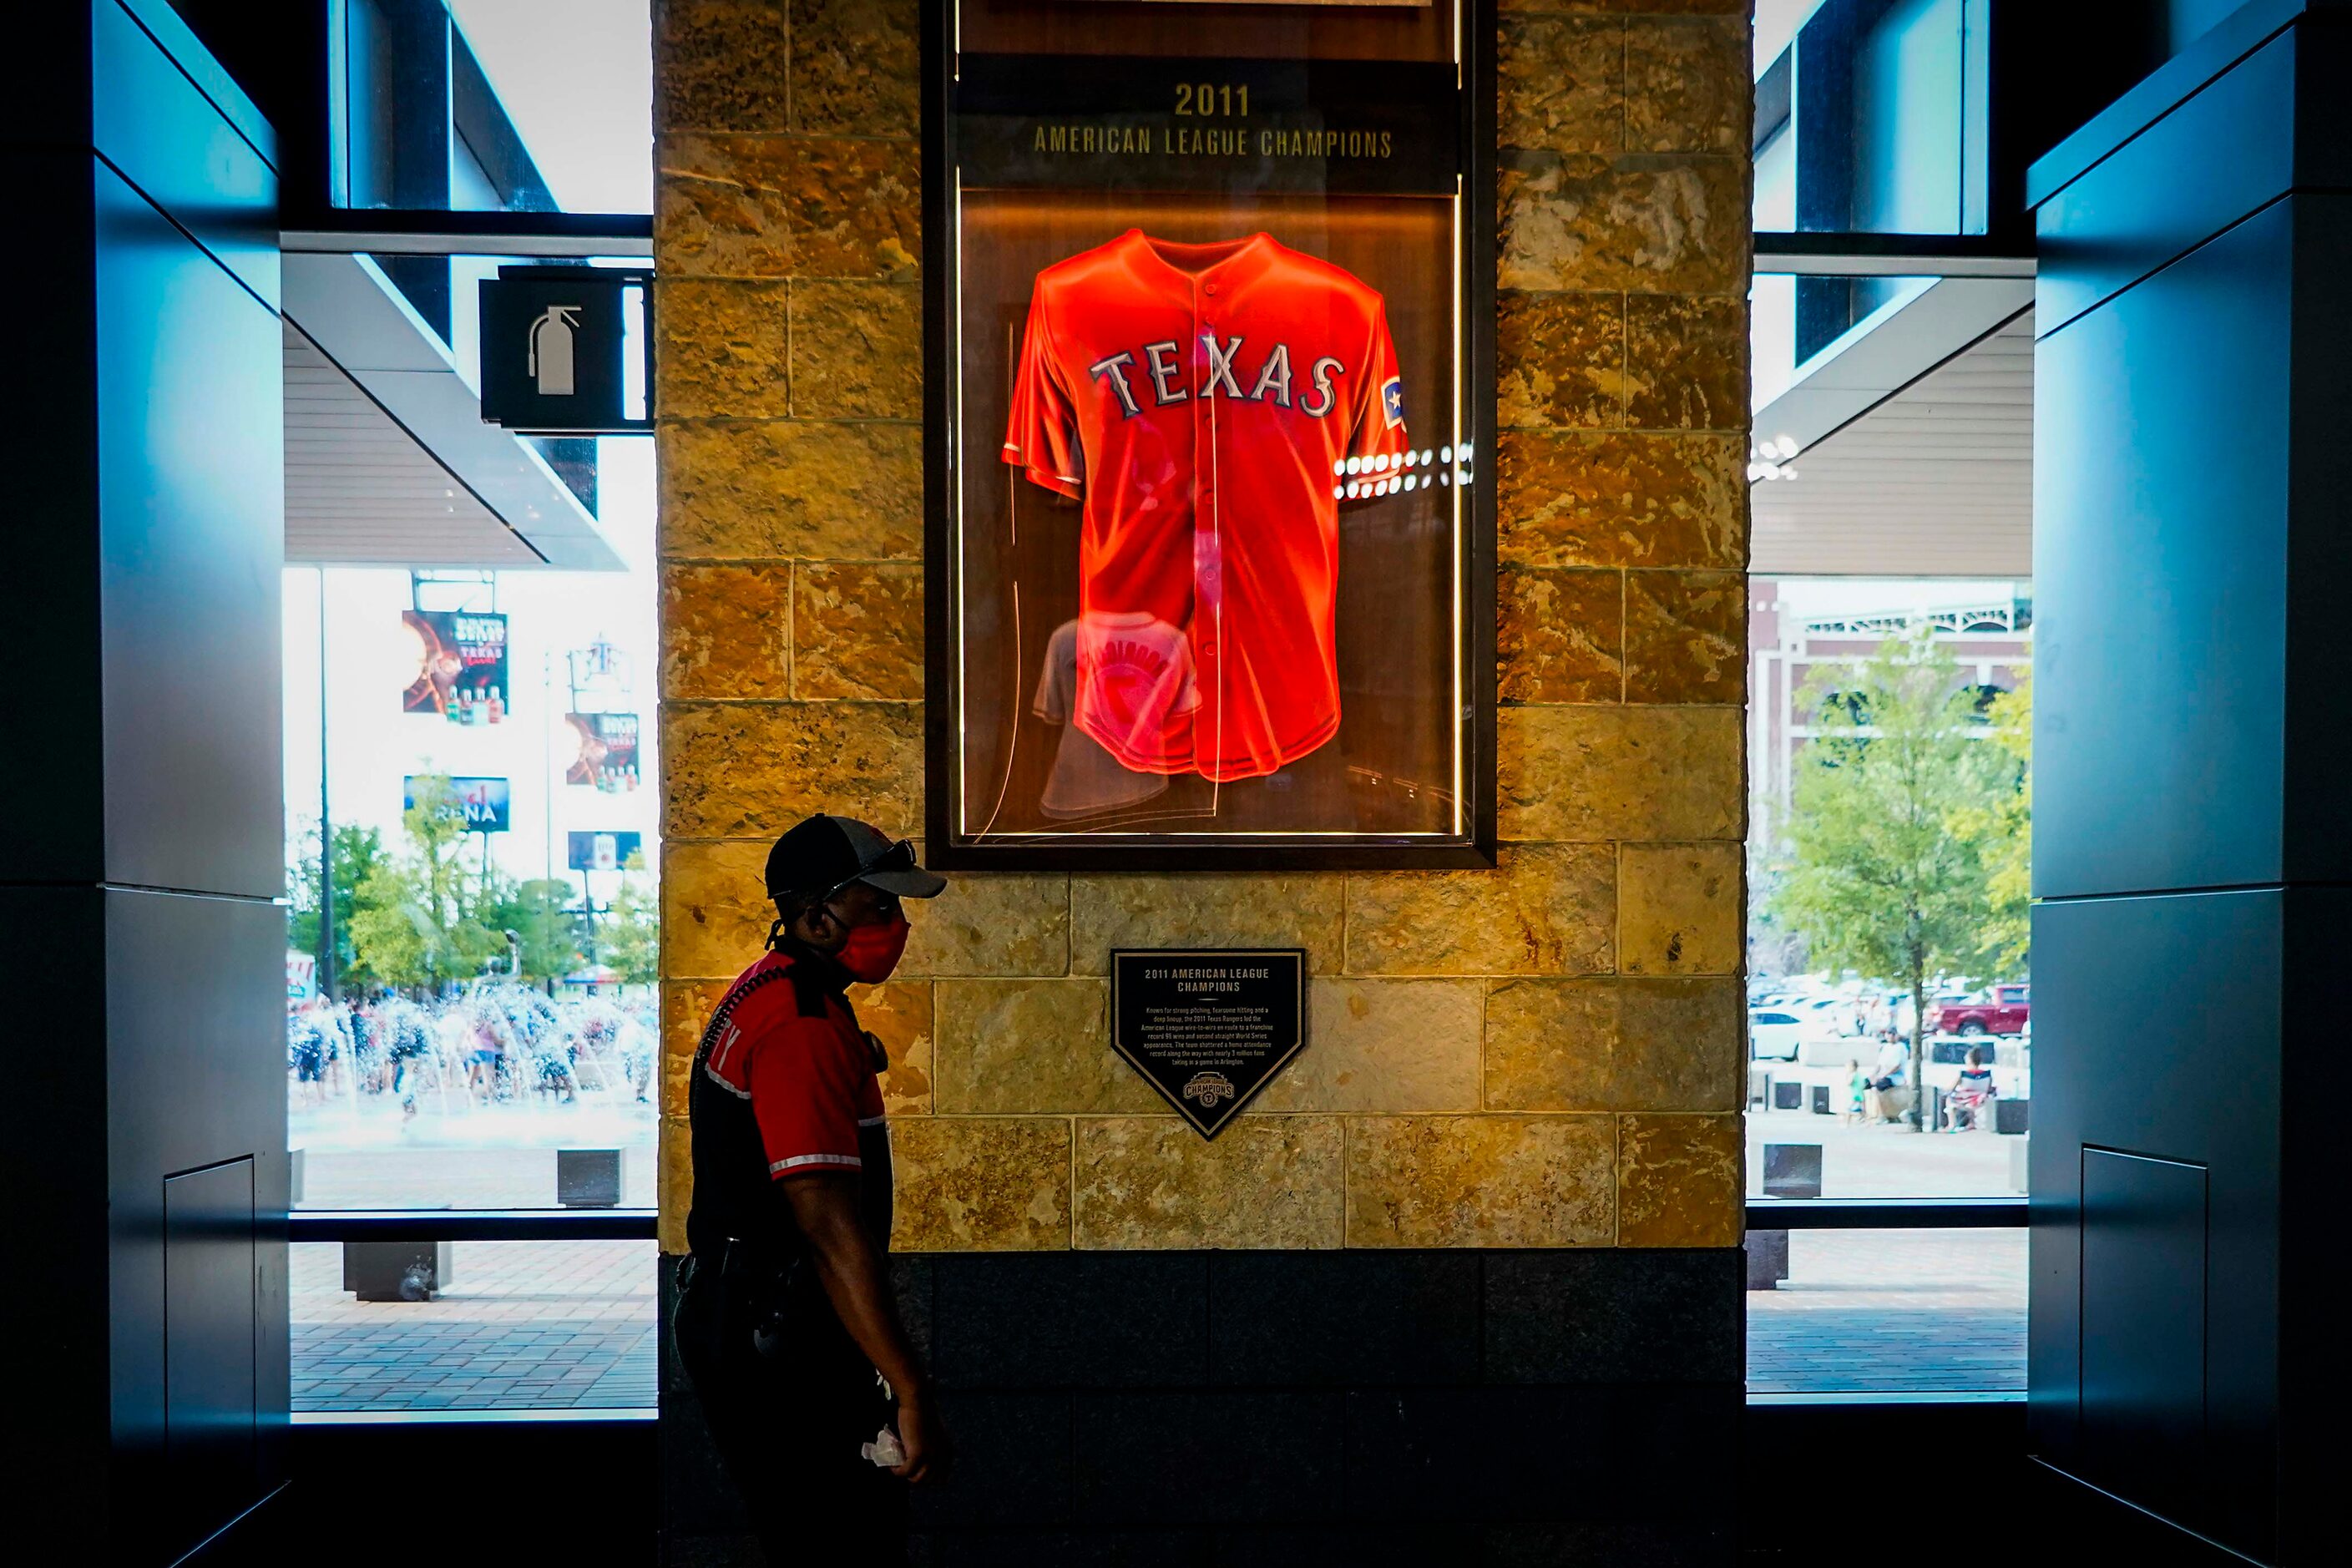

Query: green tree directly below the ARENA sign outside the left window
351 773 506 988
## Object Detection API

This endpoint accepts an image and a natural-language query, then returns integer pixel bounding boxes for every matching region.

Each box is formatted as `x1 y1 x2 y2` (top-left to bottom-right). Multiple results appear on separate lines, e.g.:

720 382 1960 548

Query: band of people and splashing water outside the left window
287 980 661 1116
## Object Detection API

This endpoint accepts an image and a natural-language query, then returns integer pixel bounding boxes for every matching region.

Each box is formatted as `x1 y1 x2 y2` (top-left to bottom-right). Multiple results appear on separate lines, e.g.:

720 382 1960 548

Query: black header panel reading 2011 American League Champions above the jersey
955 54 1463 195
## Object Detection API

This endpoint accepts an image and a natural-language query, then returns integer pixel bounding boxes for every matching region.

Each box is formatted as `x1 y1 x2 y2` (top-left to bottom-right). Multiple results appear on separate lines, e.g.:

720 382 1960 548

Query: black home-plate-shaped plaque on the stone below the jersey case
1110 948 1308 1138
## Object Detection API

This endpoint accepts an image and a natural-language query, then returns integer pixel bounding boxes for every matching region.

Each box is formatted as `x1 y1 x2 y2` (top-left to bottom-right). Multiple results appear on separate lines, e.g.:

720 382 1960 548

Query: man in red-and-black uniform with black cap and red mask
677 816 948 1563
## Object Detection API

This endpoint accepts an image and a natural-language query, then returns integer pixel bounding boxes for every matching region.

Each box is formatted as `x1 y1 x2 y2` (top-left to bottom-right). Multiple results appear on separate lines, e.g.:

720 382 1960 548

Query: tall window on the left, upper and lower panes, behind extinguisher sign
285 0 663 1418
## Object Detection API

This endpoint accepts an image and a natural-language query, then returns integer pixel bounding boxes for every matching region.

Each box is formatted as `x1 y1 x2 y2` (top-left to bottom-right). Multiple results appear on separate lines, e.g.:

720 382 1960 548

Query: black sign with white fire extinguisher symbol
480 266 654 435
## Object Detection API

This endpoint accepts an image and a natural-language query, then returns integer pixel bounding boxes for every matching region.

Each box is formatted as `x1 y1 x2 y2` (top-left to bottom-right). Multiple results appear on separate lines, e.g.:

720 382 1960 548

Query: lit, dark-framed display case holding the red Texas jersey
924 0 1496 870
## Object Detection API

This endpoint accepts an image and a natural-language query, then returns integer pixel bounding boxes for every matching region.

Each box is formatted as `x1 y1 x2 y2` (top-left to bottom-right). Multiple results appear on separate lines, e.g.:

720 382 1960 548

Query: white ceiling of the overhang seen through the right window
1748 311 2035 579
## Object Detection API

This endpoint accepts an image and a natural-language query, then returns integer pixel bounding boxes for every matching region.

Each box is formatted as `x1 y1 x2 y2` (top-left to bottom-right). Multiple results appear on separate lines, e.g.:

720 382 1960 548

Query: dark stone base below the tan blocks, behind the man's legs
661 1248 1745 1568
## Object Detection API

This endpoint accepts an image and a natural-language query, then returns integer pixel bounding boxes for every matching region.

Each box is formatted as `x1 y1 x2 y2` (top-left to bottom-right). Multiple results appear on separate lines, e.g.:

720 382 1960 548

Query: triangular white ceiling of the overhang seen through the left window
285 322 541 567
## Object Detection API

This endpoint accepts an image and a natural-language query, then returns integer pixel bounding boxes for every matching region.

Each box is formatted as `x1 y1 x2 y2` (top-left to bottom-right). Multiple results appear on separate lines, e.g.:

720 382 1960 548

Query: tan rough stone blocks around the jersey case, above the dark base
654 0 1750 1253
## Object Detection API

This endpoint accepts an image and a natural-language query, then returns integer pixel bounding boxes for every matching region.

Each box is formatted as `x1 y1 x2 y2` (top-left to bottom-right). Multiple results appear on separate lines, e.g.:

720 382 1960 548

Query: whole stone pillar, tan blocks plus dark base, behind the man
654 0 1750 1561
